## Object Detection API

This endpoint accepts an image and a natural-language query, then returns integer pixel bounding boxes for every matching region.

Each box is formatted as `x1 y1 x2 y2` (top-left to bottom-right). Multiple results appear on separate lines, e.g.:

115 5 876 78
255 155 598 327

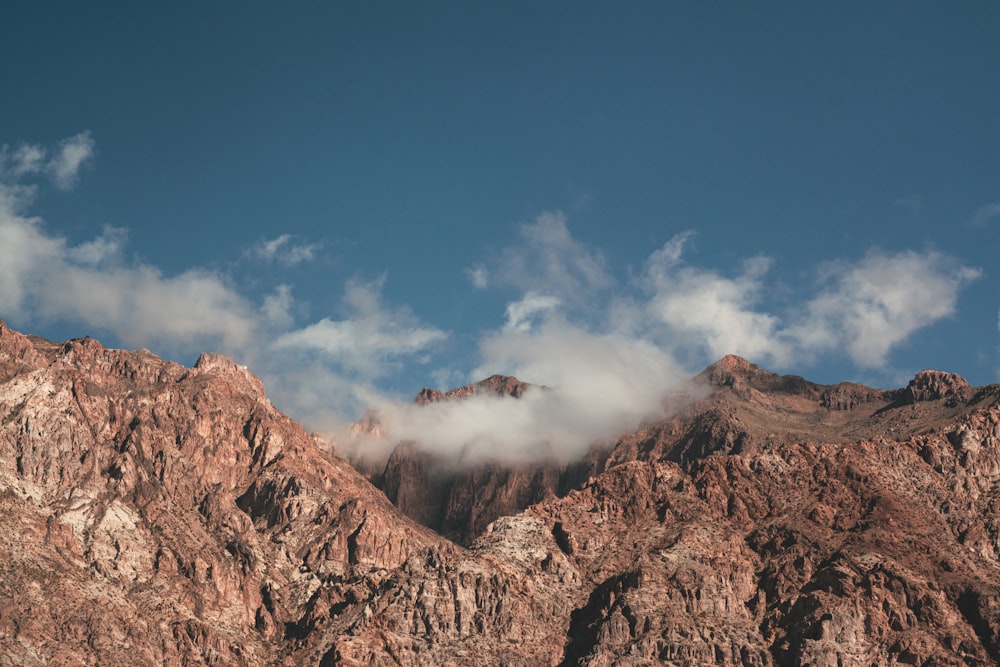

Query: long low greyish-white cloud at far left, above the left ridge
0 202 255 353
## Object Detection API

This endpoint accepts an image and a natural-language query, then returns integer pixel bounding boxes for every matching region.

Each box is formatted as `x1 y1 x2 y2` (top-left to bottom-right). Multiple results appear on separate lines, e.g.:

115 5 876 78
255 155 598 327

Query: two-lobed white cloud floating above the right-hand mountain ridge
640 233 981 368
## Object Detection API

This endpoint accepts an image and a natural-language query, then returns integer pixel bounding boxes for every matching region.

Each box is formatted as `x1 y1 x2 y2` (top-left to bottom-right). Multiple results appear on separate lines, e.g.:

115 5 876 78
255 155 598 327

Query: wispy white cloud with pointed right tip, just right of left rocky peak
271 277 448 377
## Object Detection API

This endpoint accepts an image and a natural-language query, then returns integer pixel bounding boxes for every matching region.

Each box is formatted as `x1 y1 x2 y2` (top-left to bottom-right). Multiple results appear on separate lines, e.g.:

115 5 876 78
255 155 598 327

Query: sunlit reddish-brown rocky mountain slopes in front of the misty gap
0 324 1000 665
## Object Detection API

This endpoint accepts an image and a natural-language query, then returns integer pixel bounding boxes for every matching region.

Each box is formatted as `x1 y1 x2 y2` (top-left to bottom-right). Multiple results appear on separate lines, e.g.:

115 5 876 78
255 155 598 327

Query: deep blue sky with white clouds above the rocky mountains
0 0 1000 464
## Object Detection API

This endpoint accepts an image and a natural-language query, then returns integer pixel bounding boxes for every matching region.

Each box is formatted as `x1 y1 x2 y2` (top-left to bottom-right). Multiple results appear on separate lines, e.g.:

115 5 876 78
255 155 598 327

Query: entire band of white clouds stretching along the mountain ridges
0 132 981 460
